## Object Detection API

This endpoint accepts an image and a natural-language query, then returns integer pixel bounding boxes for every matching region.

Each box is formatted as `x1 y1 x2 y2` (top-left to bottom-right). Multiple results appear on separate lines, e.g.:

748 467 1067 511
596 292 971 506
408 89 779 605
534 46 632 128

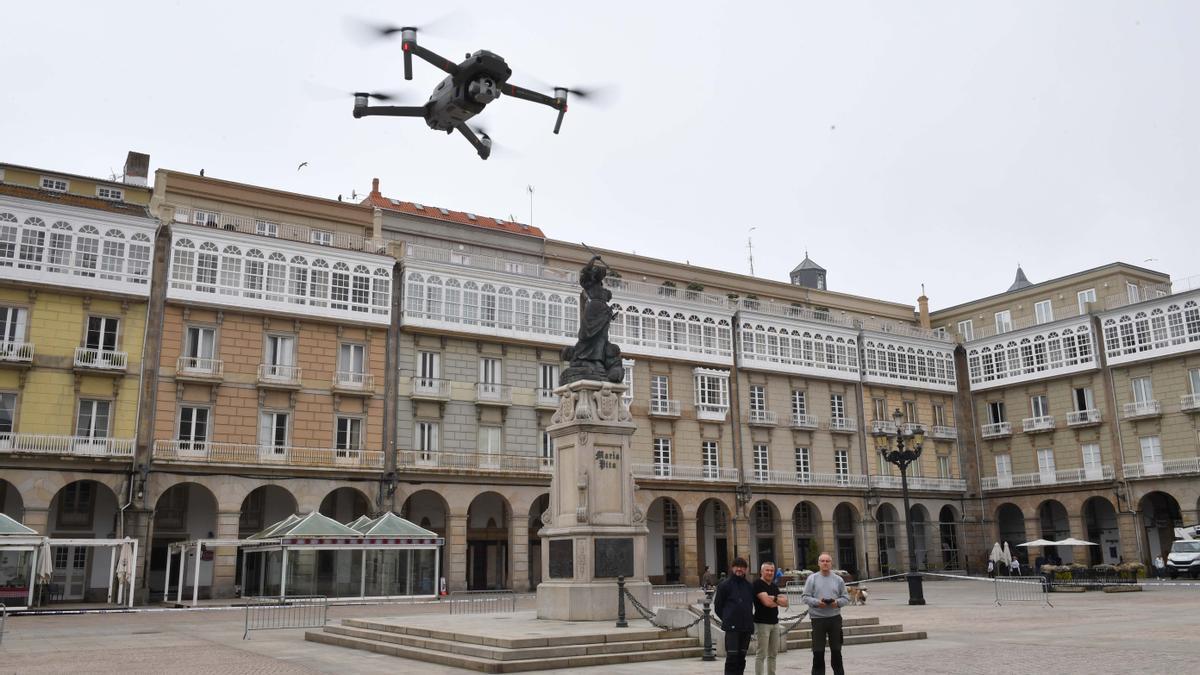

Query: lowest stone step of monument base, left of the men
305 631 704 673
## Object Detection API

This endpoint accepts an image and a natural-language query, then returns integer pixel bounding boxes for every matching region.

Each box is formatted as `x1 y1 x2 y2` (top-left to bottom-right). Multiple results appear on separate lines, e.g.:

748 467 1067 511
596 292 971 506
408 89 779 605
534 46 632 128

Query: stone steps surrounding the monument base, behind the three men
305 610 926 673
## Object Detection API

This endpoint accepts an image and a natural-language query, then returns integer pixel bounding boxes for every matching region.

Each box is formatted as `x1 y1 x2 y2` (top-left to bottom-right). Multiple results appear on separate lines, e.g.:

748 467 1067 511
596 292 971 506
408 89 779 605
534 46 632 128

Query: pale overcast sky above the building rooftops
0 0 1200 309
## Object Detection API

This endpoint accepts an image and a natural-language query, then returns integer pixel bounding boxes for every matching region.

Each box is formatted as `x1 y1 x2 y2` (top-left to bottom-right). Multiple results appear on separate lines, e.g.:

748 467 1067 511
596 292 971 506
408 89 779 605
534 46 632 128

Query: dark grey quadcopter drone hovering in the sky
354 26 588 160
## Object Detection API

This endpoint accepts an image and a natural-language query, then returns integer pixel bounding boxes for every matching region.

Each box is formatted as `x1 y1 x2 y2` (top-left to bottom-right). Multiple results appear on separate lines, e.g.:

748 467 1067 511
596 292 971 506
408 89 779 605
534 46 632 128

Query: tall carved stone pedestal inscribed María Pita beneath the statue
538 380 650 621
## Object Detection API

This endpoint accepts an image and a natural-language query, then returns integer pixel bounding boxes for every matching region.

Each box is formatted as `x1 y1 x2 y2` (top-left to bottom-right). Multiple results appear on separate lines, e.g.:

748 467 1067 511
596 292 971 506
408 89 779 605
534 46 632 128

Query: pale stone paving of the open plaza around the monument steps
0 580 1200 675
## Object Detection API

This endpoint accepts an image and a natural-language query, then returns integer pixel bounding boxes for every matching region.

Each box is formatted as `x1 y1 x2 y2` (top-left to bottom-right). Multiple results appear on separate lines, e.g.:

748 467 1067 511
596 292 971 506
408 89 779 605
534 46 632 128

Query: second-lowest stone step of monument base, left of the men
325 625 696 661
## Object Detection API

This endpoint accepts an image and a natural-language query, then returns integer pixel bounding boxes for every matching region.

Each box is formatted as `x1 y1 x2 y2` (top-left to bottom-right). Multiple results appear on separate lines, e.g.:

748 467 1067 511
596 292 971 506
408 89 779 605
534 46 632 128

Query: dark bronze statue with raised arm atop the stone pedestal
558 256 625 386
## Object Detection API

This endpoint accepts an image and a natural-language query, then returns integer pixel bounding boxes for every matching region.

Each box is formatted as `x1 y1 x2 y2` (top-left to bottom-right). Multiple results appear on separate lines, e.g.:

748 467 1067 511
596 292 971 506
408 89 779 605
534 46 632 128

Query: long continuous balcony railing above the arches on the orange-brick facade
154 441 383 470
